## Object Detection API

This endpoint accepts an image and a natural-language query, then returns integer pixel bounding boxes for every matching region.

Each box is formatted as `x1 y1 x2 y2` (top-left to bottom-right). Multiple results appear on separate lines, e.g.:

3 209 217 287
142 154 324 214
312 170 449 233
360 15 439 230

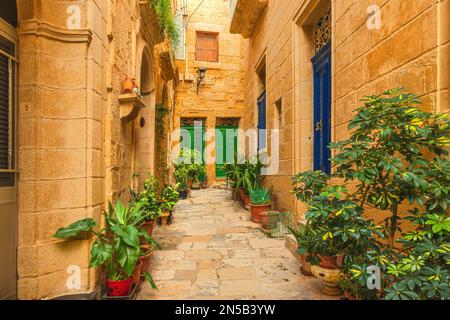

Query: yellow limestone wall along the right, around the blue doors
244 0 450 217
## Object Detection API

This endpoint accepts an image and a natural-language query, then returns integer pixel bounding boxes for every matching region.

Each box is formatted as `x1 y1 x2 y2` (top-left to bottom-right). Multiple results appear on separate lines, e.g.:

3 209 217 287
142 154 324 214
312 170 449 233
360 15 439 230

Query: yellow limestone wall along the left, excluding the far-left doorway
18 0 172 299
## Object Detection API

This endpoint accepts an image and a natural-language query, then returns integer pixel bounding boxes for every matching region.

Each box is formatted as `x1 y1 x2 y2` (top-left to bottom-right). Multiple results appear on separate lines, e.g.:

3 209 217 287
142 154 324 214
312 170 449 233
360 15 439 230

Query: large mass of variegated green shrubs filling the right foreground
293 89 450 300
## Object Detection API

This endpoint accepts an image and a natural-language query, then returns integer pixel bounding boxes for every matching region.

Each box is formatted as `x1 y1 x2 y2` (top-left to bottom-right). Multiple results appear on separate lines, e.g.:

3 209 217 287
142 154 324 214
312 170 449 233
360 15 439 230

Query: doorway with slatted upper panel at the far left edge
0 0 18 300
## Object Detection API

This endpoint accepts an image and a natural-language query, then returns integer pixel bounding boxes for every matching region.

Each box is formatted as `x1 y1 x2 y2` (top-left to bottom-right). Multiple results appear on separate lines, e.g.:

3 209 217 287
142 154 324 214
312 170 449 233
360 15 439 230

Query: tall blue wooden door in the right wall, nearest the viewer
312 42 331 174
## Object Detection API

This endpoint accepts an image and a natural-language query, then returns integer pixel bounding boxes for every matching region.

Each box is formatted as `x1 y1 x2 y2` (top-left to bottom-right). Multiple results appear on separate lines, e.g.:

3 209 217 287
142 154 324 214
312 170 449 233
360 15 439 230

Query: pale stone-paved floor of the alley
138 189 330 300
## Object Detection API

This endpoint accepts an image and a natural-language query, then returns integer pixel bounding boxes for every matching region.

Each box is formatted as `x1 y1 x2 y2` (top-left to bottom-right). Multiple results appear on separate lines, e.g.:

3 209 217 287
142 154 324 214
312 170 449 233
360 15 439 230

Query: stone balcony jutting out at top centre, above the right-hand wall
230 0 269 39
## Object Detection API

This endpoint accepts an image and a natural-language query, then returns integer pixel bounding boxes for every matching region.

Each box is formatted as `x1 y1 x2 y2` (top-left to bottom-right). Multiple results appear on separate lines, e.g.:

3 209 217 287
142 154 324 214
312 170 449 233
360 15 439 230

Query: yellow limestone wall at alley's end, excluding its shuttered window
174 0 244 183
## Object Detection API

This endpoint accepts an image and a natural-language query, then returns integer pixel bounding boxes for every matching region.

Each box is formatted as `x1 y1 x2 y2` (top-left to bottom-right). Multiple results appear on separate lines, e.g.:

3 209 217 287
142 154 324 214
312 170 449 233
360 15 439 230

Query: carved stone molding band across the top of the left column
19 20 92 43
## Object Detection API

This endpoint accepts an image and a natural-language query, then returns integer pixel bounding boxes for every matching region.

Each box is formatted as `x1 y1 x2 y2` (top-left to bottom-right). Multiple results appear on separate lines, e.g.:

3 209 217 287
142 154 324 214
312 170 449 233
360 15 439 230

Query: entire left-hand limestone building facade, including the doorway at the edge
0 0 176 299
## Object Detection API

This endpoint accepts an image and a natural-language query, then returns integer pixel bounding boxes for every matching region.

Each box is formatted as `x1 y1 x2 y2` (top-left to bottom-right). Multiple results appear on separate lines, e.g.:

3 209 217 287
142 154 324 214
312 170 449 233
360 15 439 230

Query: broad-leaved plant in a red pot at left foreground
54 201 156 297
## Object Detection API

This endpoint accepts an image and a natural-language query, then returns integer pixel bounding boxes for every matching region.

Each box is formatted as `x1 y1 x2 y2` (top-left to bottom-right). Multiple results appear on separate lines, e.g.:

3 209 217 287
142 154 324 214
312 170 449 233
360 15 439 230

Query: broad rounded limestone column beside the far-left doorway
18 0 107 299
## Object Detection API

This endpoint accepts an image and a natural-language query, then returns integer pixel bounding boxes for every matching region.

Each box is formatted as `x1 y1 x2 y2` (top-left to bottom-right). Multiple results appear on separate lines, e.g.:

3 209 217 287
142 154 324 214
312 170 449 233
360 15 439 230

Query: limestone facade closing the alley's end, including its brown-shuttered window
173 0 244 184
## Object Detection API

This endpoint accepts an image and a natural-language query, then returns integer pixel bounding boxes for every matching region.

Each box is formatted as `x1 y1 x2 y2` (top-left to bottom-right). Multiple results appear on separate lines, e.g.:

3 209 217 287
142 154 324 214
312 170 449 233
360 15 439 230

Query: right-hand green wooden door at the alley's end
216 126 238 179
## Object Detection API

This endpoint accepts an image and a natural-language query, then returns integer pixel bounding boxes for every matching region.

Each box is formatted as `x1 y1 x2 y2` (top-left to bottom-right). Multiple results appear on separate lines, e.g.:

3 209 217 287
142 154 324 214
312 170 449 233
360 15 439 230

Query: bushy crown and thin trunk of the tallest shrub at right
331 89 450 247
